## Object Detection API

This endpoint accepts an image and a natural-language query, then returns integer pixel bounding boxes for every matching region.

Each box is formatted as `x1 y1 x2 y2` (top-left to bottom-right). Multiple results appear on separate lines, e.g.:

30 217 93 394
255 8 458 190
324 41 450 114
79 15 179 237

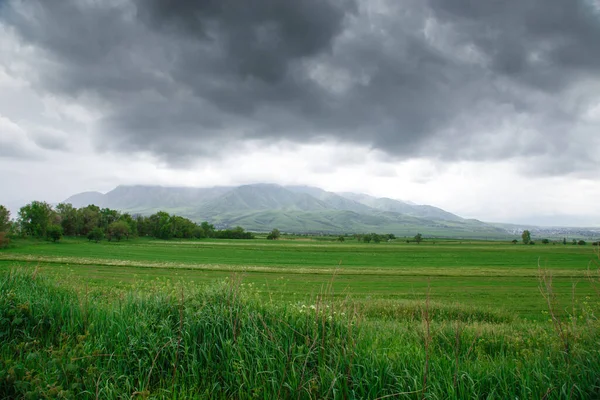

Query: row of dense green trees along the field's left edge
0 201 254 246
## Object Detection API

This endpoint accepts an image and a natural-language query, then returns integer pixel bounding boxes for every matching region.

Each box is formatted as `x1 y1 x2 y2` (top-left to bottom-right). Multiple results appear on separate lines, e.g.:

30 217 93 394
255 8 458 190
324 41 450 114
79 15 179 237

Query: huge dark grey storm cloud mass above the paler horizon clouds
0 0 600 174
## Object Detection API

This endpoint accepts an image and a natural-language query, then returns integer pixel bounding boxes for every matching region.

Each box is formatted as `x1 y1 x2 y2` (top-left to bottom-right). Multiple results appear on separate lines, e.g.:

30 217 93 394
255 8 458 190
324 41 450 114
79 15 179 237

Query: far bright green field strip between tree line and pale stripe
0 239 594 271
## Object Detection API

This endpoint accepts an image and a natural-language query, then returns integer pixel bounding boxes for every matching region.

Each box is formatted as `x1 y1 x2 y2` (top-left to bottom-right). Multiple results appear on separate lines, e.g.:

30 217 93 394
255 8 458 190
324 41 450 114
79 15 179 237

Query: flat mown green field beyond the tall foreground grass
0 239 596 319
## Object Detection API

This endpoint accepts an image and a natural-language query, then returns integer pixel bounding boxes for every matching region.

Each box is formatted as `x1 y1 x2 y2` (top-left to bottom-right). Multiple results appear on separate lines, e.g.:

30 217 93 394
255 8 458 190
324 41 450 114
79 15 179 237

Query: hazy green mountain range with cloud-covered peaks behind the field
64 184 508 238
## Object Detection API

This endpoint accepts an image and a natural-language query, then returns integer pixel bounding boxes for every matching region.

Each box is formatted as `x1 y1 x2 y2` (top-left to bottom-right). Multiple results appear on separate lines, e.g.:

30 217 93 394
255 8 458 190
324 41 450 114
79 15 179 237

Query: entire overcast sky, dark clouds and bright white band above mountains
0 0 600 226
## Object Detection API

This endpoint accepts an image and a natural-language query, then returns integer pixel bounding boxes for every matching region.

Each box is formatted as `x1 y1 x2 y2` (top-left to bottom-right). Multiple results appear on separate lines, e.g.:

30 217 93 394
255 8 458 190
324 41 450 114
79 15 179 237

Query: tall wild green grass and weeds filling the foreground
0 270 600 399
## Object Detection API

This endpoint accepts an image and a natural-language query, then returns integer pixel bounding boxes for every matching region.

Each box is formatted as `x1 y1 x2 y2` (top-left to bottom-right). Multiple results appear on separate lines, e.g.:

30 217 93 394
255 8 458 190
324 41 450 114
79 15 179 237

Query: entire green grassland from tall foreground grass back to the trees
0 238 600 399
